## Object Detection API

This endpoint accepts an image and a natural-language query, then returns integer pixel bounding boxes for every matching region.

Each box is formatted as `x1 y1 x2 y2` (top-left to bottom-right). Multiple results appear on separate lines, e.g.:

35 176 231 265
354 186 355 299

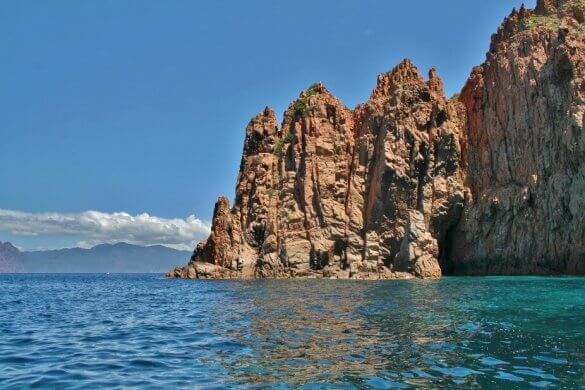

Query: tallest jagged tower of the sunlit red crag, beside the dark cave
348 60 463 277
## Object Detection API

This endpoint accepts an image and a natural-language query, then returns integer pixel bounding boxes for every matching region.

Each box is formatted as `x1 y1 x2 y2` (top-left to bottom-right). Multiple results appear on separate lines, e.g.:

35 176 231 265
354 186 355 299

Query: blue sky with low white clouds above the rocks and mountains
0 0 535 250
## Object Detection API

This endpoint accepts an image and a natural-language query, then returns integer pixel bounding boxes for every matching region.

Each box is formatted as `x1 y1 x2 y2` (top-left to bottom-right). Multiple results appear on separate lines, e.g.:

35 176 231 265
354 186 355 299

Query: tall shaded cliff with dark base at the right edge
448 0 585 274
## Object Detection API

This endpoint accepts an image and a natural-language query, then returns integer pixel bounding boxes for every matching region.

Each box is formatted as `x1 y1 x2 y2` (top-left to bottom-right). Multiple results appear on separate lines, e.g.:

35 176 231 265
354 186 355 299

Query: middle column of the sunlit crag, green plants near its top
278 84 353 274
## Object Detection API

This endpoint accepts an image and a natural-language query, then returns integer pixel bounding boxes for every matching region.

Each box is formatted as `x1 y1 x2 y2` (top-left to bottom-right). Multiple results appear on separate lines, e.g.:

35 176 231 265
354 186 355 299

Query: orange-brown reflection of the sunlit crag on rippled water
214 281 450 385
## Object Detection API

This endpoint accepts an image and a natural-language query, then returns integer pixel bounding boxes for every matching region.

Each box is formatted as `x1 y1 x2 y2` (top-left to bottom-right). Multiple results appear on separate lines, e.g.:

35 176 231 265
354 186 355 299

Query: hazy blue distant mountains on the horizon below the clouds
0 242 191 273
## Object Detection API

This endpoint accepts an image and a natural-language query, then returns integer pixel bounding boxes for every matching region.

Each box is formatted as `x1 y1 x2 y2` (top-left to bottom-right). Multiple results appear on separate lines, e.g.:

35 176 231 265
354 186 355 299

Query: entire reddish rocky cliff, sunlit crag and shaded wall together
168 0 585 279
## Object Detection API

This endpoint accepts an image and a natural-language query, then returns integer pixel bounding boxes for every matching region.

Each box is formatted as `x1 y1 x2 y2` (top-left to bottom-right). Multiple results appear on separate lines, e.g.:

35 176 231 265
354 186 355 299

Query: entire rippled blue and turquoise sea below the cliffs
0 275 585 389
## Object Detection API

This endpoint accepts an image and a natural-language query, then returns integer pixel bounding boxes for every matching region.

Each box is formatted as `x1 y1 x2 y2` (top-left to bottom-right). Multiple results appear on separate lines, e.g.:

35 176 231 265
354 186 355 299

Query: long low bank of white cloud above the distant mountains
0 209 210 250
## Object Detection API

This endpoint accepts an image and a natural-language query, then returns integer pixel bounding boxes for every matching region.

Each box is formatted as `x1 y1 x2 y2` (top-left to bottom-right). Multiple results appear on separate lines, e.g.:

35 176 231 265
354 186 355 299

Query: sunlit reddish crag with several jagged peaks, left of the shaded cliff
169 67 464 279
